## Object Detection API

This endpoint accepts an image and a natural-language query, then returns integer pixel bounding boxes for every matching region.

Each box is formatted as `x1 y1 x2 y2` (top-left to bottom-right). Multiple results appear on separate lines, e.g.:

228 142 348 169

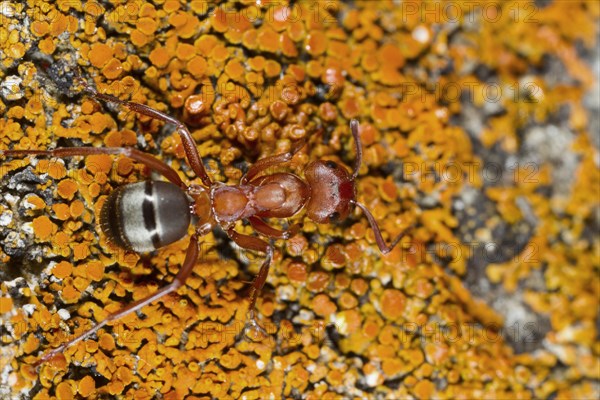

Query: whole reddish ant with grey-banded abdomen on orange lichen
0 82 402 366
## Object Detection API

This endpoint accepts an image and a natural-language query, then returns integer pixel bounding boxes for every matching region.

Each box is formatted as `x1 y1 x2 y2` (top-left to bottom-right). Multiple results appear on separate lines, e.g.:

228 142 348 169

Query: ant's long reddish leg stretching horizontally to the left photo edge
0 147 187 189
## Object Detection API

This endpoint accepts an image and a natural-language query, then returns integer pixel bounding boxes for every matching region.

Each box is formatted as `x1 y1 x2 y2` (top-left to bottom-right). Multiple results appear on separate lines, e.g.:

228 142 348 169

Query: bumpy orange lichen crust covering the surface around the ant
0 1 600 399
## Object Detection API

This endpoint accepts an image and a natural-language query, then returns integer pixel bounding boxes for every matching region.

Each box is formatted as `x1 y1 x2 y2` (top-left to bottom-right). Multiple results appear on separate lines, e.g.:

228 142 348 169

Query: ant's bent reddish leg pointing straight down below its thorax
227 228 273 337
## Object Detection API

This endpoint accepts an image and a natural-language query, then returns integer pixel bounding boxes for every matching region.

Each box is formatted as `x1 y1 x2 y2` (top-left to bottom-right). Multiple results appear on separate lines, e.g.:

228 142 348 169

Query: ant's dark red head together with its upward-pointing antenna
304 119 362 224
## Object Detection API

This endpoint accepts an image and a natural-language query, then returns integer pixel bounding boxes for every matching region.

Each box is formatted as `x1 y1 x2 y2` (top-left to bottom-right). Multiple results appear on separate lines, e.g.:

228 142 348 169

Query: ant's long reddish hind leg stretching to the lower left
34 234 198 366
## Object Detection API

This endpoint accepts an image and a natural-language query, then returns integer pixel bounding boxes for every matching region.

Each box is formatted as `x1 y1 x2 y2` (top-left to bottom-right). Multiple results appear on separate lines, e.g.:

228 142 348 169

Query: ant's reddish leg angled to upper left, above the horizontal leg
85 85 212 187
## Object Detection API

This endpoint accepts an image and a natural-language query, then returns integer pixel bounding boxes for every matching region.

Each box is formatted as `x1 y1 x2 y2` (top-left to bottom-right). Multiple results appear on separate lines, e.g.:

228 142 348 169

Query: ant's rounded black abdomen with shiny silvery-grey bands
100 181 191 253
